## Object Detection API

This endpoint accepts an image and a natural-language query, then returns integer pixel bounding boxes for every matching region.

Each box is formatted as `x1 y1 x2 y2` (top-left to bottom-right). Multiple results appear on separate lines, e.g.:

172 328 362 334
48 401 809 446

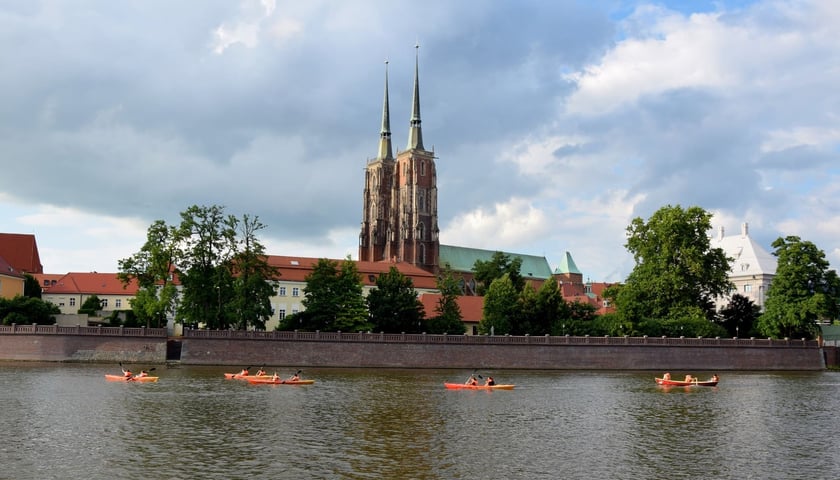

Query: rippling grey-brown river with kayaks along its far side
0 363 840 480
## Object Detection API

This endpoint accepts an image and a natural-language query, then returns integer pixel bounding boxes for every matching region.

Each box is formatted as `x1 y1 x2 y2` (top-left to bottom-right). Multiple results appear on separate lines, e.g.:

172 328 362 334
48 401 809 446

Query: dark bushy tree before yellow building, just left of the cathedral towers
282 258 371 332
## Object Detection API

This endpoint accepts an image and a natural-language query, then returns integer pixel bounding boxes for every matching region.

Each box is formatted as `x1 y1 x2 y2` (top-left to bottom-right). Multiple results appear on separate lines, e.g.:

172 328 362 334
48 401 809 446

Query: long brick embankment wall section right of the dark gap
181 337 825 371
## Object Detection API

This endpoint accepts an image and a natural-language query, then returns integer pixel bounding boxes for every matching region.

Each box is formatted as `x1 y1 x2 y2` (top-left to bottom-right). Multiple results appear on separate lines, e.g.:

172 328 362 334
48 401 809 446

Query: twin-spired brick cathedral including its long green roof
358 47 606 316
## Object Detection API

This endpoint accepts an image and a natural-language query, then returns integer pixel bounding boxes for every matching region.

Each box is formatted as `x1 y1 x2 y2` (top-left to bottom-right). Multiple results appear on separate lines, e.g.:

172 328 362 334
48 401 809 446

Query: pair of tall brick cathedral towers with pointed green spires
359 46 440 272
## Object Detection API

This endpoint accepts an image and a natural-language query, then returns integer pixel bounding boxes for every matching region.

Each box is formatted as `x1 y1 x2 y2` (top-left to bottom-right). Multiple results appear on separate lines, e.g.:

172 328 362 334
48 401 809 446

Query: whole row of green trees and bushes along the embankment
0 205 840 338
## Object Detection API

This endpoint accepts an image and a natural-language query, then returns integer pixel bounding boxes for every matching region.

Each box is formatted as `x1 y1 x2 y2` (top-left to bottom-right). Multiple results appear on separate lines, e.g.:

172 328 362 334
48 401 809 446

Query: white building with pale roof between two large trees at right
711 223 777 311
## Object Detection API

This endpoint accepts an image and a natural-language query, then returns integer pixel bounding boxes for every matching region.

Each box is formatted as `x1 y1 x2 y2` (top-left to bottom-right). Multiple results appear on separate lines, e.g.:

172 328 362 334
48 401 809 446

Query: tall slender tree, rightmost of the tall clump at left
231 215 280 330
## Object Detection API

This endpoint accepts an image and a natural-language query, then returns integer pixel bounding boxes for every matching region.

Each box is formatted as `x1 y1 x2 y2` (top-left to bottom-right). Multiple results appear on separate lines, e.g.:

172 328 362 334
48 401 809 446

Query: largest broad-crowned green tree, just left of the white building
615 205 732 322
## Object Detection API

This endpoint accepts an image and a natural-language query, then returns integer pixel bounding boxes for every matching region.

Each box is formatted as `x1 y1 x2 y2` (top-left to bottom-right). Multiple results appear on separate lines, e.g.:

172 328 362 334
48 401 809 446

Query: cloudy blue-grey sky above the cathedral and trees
0 0 840 282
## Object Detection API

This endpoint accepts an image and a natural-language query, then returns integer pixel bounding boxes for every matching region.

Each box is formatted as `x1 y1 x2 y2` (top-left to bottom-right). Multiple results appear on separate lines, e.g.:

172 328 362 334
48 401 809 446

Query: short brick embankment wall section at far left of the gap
0 335 166 364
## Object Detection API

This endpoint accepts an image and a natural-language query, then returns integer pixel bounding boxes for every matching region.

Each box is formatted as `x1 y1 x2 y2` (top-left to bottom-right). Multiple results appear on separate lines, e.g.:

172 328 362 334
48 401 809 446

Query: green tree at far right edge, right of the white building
757 236 840 338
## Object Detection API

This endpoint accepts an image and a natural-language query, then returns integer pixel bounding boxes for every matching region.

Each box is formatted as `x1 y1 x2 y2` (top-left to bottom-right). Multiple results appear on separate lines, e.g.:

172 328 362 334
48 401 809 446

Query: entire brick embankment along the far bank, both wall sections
0 325 838 371
